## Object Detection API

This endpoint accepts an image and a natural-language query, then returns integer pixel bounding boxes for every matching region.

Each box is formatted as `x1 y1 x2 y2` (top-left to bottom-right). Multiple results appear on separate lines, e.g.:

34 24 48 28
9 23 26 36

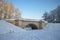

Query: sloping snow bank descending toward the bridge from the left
0 20 23 34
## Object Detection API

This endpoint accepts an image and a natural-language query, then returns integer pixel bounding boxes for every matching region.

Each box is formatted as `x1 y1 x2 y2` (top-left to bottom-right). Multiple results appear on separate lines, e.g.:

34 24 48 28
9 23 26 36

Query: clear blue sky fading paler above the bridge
6 0 60 19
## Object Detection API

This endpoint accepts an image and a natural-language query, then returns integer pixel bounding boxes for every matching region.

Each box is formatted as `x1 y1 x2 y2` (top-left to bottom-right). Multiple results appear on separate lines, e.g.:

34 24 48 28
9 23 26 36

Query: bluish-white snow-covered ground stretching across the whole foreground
0 20 60 40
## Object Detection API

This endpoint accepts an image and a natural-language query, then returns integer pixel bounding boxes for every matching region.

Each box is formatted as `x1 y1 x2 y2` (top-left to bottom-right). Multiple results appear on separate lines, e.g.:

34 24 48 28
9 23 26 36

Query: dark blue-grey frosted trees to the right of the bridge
43 6 60 23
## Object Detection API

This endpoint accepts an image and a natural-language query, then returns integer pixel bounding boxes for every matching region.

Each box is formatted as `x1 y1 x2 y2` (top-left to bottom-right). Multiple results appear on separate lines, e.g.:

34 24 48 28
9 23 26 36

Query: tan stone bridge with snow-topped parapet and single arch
7 19 43 29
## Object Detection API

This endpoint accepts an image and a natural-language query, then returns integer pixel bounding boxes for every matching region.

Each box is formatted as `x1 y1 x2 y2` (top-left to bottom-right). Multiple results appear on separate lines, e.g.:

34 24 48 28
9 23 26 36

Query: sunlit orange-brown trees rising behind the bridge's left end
0 0 20 19
